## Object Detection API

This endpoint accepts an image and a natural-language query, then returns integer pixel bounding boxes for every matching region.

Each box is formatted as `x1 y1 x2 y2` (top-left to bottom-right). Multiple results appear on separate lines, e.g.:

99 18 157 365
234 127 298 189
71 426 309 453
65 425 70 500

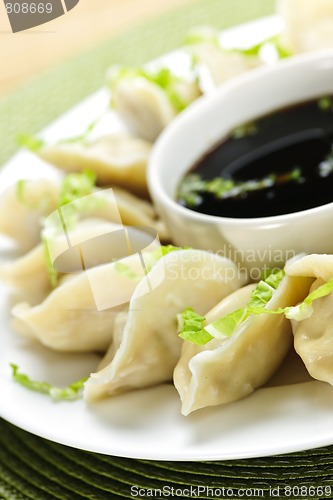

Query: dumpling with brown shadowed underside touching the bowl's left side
38 134 151 195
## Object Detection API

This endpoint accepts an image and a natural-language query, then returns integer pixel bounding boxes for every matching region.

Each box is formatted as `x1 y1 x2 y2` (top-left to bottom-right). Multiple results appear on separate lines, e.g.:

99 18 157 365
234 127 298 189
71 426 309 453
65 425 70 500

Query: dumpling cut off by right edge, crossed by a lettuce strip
286 254 333 385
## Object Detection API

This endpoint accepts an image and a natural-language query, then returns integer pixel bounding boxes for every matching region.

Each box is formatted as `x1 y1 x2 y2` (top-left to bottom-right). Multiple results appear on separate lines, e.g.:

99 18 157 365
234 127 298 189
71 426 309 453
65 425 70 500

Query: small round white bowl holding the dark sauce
148 51 333 277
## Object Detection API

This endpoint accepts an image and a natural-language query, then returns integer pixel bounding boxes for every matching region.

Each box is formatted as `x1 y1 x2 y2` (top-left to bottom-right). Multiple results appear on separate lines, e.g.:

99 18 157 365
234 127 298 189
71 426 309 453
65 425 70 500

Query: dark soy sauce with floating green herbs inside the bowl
178 97 333 218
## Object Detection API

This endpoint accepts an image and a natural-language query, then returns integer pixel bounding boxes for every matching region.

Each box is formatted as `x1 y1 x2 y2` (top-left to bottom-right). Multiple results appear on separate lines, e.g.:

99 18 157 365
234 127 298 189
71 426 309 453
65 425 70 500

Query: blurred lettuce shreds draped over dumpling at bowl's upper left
109 67 193 112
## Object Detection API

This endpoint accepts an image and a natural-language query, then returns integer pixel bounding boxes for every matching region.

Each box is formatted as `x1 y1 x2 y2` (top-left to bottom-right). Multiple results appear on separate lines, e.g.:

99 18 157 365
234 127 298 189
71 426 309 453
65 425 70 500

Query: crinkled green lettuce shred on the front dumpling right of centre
179 270 285 345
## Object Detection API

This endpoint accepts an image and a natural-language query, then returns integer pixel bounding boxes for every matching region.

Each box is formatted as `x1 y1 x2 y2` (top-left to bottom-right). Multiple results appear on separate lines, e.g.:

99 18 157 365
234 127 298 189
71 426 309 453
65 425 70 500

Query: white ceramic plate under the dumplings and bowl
0 18 333 460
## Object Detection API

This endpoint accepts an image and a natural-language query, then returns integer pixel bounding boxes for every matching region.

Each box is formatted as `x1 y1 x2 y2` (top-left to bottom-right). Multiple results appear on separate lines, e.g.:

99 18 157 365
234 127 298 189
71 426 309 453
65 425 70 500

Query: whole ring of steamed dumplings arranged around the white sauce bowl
0 0 333 415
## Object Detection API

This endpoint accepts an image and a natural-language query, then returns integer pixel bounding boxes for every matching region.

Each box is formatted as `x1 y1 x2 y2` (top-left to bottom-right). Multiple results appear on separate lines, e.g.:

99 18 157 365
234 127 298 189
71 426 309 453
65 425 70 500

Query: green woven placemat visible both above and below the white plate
0 0 333 500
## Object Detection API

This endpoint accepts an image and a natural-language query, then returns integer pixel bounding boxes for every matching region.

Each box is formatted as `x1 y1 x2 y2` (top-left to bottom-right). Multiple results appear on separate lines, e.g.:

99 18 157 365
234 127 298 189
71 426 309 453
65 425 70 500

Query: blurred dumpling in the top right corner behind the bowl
278 0 333 53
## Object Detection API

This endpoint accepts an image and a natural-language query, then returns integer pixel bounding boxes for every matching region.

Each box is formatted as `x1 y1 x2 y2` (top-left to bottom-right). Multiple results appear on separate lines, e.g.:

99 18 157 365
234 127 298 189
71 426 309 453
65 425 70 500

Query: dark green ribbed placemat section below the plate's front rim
0 420 333 500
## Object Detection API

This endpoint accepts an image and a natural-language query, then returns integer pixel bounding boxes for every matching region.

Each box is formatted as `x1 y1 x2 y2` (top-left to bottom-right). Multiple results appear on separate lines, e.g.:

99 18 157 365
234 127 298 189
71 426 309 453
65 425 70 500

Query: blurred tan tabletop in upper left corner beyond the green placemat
0 0 192 98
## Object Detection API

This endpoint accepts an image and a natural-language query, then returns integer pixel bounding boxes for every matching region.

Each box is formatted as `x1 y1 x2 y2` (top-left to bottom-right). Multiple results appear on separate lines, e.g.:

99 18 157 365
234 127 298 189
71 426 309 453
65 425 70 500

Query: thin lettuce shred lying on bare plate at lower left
10 363 87 401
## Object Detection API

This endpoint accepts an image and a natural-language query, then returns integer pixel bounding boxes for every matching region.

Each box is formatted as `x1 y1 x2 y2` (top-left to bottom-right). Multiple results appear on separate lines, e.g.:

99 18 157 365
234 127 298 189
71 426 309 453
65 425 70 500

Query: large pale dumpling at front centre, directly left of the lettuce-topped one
84 250 244 402
